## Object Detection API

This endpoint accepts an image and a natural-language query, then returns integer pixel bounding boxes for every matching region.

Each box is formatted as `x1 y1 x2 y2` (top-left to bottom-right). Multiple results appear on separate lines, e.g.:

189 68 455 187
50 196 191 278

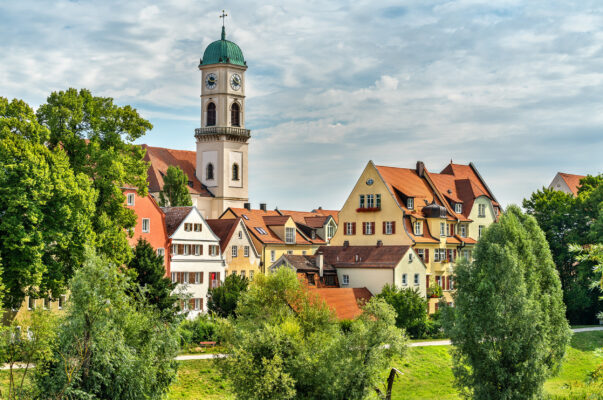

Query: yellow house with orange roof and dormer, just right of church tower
220 207 327 273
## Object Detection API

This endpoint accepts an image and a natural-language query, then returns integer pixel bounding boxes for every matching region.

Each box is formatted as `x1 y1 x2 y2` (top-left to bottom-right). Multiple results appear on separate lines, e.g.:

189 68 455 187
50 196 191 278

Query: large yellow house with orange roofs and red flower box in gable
331 161 500 312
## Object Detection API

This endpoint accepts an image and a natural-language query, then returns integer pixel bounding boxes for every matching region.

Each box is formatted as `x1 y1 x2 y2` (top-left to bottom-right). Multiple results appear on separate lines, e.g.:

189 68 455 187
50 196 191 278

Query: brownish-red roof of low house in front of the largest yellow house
315 246 410 269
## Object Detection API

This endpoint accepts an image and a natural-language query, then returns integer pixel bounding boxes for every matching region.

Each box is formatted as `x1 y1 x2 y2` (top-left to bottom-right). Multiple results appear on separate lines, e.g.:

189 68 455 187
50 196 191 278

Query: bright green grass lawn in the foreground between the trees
168 331 603 400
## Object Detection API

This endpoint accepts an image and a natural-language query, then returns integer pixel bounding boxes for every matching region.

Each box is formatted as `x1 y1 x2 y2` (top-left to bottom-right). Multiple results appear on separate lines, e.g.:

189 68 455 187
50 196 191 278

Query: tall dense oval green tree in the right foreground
444 206 571 400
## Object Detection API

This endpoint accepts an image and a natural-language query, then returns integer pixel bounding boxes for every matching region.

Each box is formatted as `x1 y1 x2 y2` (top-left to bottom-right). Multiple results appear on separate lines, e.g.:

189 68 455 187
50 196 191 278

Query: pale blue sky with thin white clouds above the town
0 0 603 210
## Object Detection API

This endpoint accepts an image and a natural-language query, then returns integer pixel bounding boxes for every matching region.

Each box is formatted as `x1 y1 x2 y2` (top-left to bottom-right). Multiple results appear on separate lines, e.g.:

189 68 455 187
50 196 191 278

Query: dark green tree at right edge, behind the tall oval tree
523 176 603 324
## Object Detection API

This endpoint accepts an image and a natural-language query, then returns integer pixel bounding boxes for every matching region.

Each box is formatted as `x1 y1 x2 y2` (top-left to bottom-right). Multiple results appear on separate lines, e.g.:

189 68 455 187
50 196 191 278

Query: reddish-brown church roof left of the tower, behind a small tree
142 144 213 197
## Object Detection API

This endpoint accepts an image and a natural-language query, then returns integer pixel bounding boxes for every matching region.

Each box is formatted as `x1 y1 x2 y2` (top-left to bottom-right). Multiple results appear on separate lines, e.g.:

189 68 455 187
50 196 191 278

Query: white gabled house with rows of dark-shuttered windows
163 207 226 318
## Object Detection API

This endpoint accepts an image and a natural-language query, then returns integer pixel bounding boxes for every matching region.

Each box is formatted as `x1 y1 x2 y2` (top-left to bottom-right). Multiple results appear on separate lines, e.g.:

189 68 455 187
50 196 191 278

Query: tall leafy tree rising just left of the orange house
36 89 153 265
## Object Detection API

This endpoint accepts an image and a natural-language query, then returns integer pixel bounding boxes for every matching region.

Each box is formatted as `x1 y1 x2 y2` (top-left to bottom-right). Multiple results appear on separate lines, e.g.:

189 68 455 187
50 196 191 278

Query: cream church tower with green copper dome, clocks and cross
195 13 251 218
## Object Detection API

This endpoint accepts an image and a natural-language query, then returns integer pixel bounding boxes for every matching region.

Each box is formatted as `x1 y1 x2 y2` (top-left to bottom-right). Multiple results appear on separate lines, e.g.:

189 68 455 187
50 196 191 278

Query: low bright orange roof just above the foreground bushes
308 288 372 320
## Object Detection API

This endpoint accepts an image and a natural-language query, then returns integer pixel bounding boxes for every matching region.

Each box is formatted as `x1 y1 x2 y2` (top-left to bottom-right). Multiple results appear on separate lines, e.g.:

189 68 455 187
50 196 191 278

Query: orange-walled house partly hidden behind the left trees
123 188 170 276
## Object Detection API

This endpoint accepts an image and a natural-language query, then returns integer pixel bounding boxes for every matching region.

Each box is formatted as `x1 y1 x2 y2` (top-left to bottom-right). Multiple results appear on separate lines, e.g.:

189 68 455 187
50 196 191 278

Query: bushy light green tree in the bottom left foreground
36 253 178 400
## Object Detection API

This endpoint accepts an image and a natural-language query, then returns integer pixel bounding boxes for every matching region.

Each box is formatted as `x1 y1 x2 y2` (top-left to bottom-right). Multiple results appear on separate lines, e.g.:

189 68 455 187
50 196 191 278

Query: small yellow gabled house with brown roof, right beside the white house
207 218 261 279
